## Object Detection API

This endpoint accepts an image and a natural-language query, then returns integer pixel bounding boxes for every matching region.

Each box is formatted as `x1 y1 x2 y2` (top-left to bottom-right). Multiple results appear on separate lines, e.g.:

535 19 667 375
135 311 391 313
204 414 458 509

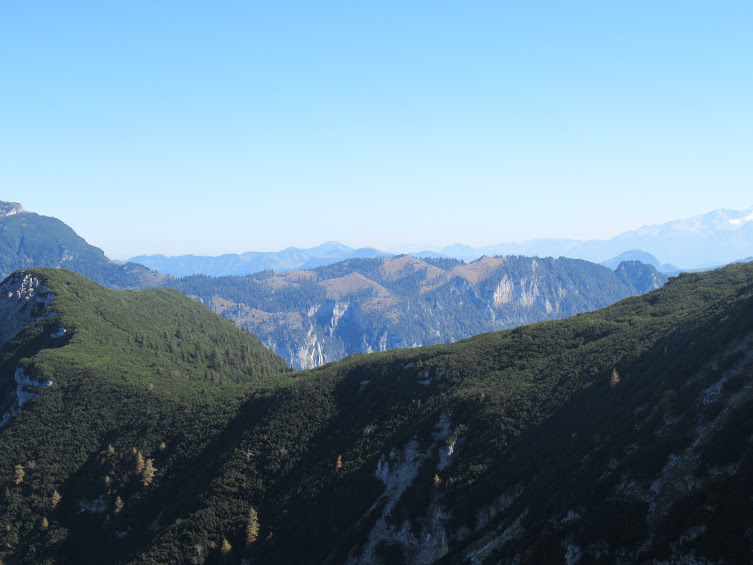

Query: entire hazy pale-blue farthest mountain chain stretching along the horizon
129 208 753 277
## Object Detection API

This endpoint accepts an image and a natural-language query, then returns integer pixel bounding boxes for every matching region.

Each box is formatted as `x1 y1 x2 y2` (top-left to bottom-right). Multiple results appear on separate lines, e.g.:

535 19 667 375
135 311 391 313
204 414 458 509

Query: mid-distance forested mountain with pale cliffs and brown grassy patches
168 256 666 369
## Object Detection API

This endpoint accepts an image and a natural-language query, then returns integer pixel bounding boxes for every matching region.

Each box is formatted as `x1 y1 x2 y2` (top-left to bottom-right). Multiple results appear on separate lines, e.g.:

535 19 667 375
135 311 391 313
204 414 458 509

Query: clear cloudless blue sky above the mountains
0 0 753 258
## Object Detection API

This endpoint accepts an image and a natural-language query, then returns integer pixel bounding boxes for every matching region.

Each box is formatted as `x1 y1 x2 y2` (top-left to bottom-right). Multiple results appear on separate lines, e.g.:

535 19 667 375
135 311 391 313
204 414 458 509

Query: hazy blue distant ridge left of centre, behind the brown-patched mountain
129 241 392 277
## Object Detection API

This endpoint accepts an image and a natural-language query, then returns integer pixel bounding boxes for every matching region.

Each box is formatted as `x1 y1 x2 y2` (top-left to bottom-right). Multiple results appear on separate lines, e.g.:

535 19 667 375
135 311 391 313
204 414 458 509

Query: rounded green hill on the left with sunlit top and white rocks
0 269 286 563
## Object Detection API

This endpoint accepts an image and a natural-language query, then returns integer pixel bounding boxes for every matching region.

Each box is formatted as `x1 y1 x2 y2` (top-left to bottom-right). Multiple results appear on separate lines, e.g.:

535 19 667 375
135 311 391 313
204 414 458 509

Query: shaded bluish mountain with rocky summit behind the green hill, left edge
0 202 166 289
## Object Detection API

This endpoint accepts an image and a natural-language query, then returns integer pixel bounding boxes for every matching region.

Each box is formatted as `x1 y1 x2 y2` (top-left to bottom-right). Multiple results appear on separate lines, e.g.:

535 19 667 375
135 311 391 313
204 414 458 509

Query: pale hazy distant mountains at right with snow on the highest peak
434 208 753 269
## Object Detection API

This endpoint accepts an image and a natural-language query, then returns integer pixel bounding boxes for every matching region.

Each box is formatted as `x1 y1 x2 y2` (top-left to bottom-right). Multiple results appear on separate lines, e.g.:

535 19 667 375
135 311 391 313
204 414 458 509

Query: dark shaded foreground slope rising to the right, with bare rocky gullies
136 265 753 563
